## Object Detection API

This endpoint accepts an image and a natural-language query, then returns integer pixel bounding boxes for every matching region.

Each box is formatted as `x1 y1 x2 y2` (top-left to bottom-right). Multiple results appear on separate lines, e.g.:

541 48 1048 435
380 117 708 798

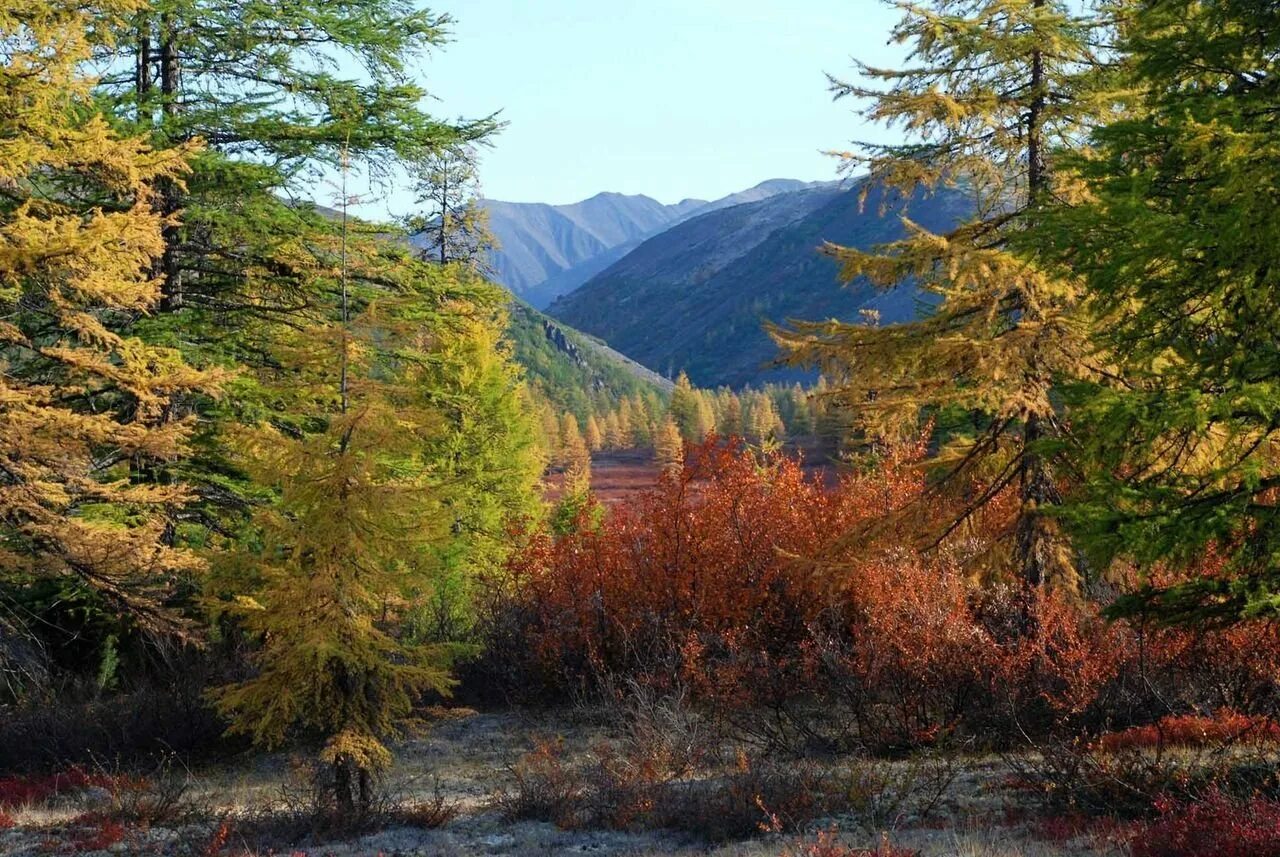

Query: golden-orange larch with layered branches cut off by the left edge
0 0 220 652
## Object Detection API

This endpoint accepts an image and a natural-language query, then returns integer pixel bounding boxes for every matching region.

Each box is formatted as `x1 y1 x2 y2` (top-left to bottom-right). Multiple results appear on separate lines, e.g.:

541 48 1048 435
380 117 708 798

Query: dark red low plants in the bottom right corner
1129 792 1280 857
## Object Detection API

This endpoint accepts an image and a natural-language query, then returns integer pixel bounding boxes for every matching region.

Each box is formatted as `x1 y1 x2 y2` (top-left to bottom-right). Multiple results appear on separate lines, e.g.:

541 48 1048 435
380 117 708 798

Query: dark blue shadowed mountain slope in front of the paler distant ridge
548 185 969 388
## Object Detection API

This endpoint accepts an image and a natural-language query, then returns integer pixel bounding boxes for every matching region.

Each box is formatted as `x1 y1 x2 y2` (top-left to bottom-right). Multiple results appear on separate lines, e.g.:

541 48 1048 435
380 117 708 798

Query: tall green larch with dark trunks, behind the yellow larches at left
96 0 497 432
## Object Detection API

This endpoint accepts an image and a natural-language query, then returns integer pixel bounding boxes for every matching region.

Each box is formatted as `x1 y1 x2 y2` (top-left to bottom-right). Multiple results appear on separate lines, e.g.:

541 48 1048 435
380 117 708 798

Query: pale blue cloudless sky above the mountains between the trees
355 0 900 212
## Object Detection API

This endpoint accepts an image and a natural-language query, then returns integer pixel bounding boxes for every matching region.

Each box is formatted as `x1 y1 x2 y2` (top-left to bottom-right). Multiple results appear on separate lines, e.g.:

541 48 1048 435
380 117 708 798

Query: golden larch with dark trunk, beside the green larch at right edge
771 0 1112 590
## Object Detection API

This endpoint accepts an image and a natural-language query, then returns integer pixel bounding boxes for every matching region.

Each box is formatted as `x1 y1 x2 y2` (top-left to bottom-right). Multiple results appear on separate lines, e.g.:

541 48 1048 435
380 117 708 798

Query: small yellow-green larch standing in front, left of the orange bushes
211 182 473 820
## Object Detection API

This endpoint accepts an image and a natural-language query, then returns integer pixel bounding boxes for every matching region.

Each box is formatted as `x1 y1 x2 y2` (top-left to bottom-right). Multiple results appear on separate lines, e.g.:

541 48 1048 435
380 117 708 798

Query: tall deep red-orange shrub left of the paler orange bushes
512 443 896 706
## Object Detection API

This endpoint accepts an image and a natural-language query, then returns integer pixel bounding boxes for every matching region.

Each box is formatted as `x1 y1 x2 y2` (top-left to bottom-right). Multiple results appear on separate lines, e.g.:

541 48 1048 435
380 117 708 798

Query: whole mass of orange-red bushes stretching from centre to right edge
490 439 1280 747
